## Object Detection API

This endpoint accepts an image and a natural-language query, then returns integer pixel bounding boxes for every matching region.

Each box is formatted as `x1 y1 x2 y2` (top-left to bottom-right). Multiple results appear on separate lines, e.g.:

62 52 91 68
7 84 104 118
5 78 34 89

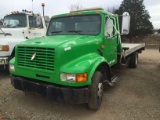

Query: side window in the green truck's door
105 18 114 37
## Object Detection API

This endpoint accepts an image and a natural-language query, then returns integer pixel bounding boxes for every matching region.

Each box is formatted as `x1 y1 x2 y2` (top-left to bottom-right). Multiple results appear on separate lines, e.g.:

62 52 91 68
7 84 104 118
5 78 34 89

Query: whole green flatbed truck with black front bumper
9 8 145 110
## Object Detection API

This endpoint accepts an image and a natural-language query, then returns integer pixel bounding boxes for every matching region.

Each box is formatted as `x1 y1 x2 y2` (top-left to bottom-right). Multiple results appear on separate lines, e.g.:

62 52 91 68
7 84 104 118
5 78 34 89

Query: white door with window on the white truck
28 16 46 39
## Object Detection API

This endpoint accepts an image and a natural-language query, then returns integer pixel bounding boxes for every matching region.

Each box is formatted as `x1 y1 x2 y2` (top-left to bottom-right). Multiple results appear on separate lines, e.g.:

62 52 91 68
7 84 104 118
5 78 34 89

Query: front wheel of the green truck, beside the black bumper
88 71 103 110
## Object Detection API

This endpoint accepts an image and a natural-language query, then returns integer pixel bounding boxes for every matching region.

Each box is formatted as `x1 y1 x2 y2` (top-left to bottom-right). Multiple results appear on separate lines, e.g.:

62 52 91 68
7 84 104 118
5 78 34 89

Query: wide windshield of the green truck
47 15 101 36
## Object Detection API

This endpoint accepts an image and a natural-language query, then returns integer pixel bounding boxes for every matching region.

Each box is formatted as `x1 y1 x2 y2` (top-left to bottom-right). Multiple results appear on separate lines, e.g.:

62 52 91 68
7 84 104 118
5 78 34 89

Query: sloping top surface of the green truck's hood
19 35 97 48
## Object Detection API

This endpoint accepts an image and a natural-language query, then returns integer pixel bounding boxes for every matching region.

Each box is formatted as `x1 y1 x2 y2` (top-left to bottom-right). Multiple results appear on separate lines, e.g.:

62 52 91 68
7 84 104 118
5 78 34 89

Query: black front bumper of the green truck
10 75 89 104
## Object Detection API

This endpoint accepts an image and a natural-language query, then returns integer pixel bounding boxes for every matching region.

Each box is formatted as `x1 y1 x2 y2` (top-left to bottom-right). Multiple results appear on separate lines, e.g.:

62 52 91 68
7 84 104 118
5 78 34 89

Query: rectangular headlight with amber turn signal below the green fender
60 73 88 82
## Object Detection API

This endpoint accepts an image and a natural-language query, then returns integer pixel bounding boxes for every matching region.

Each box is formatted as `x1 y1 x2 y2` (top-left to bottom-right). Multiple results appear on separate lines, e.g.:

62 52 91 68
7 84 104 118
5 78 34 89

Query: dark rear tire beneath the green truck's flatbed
129 52 138 68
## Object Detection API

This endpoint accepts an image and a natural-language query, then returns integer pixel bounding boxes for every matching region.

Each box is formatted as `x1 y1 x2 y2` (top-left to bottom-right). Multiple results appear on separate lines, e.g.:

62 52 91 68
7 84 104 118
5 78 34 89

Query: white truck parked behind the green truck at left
0 10 49 70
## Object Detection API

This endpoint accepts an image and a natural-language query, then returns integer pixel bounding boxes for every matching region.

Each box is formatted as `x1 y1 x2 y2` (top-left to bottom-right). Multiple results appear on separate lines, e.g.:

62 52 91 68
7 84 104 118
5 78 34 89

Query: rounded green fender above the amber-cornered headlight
60 53 108 85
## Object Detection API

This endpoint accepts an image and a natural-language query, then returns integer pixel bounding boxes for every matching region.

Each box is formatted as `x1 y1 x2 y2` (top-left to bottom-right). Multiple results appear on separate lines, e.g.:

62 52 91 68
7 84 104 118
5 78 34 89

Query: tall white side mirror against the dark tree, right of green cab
121 12 130 35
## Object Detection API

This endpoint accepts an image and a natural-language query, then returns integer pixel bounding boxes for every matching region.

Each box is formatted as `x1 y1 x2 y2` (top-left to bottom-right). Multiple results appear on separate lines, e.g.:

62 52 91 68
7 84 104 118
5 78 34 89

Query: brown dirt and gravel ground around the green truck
0 49 160 120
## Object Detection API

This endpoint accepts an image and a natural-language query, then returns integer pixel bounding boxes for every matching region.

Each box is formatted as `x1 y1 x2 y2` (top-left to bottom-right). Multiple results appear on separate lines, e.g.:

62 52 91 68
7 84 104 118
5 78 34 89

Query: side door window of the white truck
29 16 43 28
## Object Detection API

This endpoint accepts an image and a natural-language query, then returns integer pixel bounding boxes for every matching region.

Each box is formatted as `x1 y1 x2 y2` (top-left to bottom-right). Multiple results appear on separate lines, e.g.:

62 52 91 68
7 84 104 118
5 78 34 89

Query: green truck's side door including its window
103 17 118 65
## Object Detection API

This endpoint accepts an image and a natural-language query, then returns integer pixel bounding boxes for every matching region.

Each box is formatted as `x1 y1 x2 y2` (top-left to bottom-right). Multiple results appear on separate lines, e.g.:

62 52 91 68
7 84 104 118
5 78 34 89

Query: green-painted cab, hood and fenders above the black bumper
10 10 122 87
